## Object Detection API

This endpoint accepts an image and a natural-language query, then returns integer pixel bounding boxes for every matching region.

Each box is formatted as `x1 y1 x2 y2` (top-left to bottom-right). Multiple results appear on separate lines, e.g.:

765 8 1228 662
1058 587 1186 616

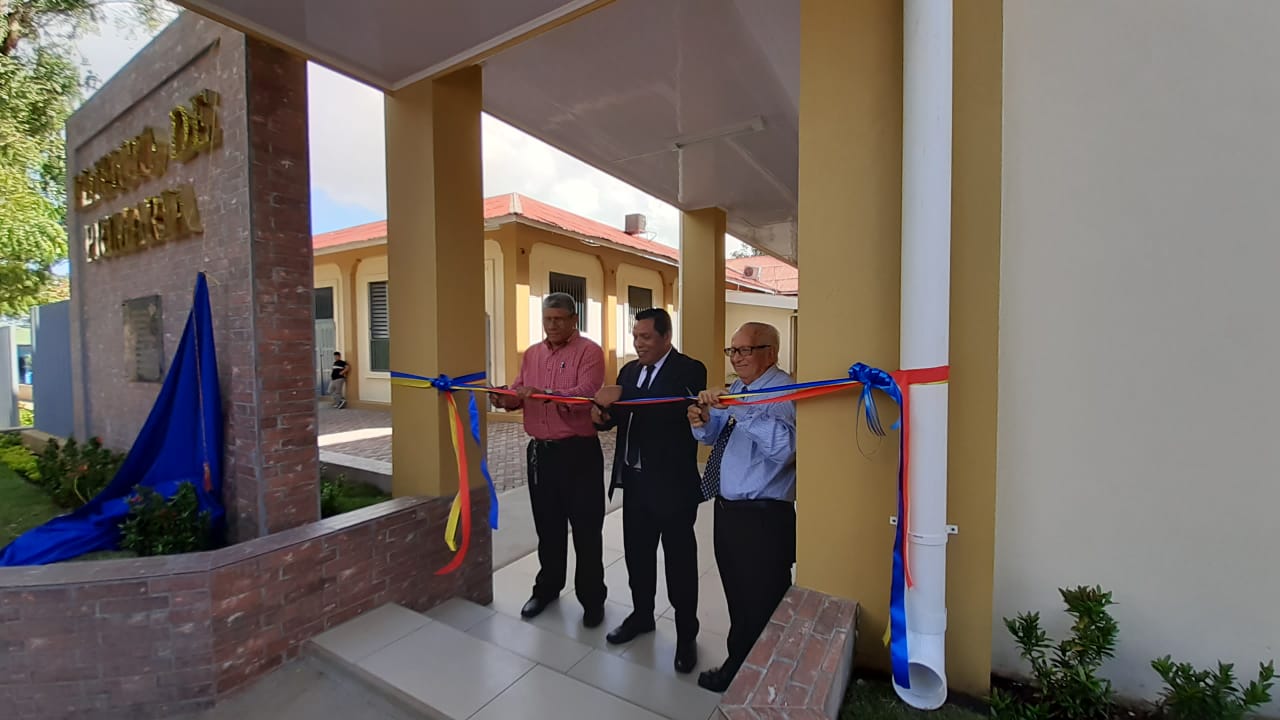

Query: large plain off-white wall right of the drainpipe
998 0 1280 714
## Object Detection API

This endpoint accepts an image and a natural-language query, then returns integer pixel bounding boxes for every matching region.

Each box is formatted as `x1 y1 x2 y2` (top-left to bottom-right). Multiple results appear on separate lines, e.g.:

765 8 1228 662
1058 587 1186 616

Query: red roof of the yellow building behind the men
311 192 799 295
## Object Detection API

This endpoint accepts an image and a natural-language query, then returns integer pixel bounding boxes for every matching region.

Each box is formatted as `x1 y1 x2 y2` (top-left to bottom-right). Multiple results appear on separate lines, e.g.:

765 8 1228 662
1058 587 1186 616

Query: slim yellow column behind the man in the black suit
678 208 726 379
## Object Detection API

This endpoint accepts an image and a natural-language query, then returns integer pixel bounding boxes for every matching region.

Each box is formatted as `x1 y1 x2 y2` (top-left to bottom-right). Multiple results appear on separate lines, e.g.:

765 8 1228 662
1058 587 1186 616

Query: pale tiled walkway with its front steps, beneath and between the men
315 505 728 720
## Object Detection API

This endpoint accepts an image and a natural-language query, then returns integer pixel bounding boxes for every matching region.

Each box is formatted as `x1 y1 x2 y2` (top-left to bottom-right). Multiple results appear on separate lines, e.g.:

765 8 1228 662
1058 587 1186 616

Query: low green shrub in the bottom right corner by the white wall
1151 655 1276 720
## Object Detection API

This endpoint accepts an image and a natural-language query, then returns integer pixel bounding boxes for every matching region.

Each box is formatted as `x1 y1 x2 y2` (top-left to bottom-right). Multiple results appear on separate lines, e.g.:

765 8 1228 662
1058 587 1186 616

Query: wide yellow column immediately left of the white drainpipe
796 0 906 669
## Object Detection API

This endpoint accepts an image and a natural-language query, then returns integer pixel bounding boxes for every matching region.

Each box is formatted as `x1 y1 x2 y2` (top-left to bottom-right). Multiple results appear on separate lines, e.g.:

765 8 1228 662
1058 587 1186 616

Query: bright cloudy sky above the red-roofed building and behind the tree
72 3 741 252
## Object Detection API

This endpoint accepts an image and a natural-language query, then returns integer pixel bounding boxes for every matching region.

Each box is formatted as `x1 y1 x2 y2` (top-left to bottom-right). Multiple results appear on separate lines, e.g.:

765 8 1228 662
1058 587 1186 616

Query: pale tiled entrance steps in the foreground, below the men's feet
300 600 719 720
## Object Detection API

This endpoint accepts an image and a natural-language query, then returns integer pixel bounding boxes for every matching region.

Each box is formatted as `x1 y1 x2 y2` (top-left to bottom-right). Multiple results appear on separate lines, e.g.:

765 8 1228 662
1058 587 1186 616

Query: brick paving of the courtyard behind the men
319 400 614 492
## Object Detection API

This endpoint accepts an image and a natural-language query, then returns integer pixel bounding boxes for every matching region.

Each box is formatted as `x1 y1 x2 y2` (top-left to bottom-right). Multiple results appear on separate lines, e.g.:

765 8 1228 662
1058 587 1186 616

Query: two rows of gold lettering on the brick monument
74 90 223 263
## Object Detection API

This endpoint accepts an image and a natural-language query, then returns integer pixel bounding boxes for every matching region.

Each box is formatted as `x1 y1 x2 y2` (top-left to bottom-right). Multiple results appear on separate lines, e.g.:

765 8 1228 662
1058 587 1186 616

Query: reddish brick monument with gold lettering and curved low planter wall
0 14 493 720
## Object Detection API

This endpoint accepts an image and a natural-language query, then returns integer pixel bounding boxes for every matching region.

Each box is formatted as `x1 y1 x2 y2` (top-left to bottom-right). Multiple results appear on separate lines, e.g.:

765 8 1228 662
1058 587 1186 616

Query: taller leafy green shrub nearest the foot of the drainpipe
991 585 1119 720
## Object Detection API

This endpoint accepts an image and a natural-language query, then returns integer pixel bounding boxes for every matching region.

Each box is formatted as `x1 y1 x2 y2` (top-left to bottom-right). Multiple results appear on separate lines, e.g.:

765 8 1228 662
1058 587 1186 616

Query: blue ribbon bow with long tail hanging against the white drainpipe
849 363 911 689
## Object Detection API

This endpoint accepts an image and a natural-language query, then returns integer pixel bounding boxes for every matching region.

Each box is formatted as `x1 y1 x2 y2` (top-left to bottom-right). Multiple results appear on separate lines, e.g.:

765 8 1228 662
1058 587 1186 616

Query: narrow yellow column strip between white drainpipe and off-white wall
947 0 1004 697
